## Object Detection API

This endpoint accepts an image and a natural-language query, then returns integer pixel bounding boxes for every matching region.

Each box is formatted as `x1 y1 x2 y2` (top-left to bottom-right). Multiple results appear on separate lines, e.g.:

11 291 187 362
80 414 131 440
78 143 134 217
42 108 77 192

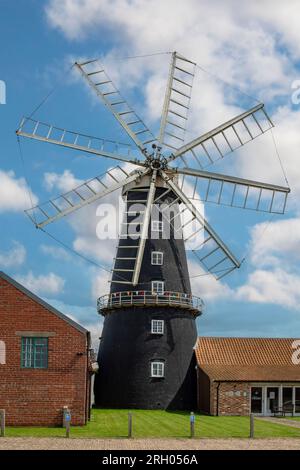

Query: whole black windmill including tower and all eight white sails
17 52 289 409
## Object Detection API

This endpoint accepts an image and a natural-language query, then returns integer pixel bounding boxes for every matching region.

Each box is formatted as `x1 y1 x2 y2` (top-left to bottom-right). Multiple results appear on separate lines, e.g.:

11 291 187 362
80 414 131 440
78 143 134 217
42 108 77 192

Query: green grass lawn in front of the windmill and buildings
6 410 300 438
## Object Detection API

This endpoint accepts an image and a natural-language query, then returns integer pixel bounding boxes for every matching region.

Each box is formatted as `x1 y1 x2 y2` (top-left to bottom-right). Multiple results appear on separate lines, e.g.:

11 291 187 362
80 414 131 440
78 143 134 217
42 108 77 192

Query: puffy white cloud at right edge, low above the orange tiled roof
236 268 300 310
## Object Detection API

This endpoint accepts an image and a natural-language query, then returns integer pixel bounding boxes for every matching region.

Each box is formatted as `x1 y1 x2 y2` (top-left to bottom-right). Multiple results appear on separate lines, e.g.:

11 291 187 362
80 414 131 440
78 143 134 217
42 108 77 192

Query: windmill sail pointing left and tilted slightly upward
16 118 144 166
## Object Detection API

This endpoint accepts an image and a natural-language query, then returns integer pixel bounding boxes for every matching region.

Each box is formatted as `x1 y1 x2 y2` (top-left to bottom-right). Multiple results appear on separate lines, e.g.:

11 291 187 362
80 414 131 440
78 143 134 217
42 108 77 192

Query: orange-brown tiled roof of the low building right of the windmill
195 337 300 381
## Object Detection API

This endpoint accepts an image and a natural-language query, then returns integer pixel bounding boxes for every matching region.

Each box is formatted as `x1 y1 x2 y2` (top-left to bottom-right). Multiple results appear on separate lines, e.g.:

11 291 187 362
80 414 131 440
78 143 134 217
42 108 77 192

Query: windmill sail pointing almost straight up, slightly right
158 52 196 150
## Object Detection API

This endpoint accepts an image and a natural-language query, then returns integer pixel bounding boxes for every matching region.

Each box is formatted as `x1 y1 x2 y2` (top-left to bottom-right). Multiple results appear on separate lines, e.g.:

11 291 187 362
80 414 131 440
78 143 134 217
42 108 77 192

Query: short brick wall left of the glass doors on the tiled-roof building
210 382 250 416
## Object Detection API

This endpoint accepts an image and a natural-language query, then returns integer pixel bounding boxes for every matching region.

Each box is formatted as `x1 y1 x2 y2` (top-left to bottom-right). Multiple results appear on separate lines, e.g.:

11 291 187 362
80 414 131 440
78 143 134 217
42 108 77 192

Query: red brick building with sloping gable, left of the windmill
0 272 91 426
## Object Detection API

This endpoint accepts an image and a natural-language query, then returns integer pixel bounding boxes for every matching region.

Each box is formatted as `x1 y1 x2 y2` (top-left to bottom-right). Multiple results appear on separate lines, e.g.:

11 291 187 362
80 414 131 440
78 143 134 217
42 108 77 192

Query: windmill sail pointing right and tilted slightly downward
178 168 290 214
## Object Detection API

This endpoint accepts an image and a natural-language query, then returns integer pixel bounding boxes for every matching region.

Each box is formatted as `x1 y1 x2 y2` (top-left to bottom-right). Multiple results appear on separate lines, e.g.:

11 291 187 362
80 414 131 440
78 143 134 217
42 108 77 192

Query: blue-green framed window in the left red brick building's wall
21 337 48 369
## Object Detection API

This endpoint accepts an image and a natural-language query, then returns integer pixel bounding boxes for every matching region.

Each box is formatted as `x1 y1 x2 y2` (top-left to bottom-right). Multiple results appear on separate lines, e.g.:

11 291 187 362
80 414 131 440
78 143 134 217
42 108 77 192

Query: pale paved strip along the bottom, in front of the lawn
0 437 300 450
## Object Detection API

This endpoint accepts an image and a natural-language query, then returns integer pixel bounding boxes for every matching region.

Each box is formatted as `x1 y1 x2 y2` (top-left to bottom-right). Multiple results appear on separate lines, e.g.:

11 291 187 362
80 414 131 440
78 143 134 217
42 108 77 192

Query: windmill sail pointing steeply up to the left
75 60 156 152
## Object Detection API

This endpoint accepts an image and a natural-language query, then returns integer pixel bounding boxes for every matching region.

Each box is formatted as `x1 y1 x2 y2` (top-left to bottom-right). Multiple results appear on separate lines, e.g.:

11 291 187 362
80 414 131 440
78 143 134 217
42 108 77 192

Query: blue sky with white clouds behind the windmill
0 0 300 346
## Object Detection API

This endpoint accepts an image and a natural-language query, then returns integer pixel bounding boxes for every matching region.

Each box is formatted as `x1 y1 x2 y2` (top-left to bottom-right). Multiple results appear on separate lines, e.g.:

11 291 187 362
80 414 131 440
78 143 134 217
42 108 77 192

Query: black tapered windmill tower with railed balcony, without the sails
95 174 201 409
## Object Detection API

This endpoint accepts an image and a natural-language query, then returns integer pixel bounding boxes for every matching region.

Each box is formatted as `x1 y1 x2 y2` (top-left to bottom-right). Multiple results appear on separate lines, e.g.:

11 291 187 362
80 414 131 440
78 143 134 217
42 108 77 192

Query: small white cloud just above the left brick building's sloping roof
17 271 65 295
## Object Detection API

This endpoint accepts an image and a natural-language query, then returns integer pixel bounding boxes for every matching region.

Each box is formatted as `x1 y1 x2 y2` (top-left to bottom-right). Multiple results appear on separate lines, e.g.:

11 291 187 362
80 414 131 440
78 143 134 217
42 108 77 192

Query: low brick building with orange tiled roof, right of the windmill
196 337 300 416
